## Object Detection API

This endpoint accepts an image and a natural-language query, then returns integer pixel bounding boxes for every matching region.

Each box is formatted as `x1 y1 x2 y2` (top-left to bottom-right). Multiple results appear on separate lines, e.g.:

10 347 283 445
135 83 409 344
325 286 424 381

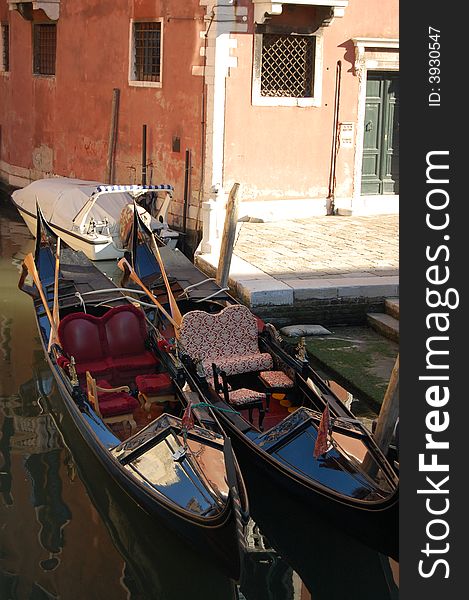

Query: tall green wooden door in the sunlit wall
361 72 399 196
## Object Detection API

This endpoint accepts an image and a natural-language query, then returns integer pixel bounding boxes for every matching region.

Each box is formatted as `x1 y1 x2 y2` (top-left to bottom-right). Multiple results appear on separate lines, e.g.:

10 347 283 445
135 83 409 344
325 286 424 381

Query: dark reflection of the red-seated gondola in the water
33 365 241 600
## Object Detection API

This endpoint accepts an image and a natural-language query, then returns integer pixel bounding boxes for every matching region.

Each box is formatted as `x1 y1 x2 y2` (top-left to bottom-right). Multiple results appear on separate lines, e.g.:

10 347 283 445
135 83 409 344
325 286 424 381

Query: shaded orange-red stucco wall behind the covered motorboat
0 0 204 224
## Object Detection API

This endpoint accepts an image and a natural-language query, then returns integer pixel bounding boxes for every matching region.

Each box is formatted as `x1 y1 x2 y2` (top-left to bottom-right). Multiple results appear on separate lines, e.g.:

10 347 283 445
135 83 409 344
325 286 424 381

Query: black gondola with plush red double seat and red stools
19 206 248 579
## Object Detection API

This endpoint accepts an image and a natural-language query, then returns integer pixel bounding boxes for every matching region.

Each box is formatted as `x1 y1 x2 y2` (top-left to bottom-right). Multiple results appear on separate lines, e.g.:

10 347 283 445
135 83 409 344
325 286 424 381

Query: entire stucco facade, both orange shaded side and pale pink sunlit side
0 0 399 228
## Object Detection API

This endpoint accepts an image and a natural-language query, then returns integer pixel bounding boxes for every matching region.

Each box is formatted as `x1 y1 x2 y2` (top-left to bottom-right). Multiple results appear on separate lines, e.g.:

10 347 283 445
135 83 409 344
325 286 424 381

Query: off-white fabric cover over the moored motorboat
12 177 166 237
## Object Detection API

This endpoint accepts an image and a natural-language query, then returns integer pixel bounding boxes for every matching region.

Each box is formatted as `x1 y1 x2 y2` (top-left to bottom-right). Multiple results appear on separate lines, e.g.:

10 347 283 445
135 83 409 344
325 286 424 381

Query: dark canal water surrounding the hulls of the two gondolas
0 192 398 600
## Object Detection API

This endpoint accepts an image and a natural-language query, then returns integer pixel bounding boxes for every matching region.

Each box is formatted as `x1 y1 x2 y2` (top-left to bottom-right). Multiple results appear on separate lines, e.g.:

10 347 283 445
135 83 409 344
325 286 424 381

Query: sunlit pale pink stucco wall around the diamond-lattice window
224 0 399 200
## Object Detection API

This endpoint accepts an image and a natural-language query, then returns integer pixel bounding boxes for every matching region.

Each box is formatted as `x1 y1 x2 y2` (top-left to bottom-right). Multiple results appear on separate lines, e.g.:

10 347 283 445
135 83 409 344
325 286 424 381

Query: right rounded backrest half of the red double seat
103 304 147 358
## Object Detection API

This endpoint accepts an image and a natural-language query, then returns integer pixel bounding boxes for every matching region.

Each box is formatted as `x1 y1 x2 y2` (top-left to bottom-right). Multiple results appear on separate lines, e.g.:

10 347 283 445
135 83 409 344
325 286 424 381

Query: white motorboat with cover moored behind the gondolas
12 177 179 260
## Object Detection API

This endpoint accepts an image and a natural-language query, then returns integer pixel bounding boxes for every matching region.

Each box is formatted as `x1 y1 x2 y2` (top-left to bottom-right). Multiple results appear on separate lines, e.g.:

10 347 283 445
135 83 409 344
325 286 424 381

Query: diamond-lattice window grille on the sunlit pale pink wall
261 33 316 98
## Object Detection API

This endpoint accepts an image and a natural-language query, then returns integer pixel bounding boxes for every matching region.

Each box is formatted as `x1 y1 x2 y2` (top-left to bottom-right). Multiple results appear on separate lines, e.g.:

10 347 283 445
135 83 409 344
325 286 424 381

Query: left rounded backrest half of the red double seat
58 313 108 364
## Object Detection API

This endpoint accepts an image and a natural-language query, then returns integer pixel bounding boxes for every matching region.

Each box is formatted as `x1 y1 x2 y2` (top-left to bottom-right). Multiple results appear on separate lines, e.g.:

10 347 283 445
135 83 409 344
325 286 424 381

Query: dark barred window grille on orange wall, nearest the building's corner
134 22 161 81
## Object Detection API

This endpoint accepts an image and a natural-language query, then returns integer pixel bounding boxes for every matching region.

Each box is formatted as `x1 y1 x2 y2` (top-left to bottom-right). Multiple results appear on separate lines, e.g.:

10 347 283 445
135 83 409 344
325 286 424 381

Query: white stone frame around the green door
352 38 399 212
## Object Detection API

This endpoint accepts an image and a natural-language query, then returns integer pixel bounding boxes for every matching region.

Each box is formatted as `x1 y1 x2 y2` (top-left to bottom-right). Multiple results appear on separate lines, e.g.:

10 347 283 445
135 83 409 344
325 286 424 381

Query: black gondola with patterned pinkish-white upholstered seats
127 204 399 559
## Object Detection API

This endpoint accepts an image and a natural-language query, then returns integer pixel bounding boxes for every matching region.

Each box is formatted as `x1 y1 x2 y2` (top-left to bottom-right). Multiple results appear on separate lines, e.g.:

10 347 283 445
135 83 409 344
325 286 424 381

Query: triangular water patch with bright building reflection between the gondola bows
239 519 311 600
